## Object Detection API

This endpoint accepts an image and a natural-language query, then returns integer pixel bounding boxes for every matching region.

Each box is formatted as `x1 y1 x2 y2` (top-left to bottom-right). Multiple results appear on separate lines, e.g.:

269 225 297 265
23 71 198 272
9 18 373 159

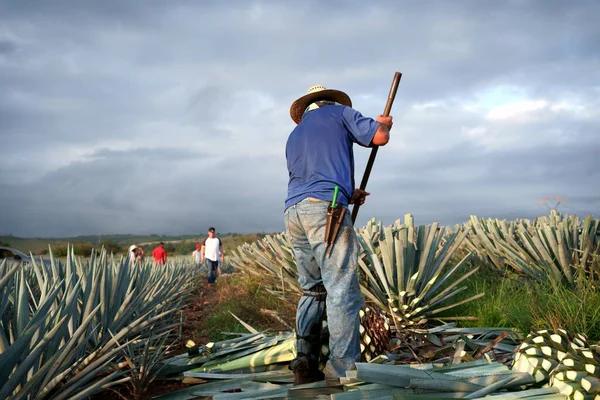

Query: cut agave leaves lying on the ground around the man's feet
149 320 565 400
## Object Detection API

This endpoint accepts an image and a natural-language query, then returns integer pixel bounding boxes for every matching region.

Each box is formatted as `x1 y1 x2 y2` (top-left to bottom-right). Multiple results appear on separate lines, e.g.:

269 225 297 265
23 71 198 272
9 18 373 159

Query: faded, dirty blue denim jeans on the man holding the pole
285 198 364 378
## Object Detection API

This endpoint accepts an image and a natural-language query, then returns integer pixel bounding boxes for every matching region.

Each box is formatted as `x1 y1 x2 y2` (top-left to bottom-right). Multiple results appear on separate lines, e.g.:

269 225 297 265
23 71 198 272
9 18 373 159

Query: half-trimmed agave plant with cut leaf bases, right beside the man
359 214 484 327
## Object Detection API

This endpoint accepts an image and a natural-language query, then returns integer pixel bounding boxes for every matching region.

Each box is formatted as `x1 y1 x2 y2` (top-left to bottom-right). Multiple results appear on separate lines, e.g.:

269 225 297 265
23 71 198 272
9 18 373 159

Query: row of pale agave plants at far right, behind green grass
465 211 600 284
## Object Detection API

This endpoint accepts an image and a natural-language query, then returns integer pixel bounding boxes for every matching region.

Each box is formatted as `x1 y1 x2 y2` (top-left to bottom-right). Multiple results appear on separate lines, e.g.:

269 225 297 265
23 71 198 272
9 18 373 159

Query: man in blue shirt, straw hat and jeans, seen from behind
285 85 392 384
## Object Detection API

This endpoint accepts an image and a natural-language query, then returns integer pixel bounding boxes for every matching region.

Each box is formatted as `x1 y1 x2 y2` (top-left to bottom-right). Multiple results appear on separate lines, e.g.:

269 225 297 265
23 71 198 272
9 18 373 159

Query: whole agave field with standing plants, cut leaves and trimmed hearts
0 211 600 400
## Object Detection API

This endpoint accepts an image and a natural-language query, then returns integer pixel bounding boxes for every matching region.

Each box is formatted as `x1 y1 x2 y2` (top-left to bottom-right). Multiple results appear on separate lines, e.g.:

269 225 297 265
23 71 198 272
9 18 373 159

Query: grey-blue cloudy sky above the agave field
0 0 600 236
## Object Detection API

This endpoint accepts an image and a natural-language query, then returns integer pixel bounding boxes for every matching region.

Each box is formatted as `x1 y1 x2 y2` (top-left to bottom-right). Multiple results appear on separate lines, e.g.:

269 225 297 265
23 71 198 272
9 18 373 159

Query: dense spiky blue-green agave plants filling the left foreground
0 245 193 399
